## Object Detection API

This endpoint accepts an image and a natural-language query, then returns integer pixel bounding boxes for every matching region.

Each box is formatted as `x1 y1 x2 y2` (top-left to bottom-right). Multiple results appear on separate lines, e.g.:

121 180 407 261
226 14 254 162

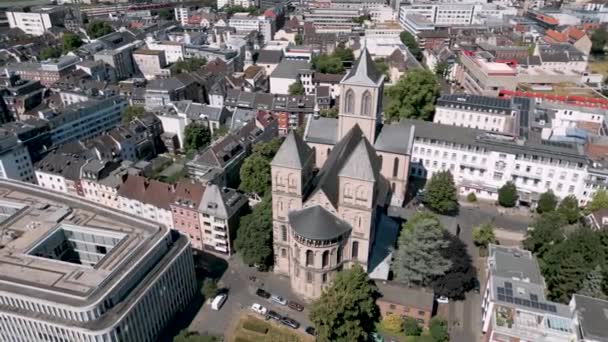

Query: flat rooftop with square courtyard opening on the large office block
0 180 170 306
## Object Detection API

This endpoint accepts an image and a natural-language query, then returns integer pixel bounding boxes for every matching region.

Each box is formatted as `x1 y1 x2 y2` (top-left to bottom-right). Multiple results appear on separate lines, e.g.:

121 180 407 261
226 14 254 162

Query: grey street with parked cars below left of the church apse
188 257 310 335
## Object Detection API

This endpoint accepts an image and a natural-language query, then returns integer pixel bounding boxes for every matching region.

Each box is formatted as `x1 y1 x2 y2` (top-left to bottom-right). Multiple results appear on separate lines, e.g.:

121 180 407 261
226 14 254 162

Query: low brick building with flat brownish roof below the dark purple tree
376 281 435 327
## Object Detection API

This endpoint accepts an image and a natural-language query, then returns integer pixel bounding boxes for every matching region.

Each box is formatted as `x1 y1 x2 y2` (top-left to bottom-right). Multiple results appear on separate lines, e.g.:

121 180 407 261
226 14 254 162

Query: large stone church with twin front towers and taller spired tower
271 49 413 299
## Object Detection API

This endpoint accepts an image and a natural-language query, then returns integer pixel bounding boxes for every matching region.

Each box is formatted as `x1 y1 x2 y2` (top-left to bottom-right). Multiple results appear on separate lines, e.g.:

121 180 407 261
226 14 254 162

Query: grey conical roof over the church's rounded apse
288 205 352 240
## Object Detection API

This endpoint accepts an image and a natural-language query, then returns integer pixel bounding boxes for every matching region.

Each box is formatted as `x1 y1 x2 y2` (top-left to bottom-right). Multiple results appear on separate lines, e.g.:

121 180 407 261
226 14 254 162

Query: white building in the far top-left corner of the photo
6 7 64 36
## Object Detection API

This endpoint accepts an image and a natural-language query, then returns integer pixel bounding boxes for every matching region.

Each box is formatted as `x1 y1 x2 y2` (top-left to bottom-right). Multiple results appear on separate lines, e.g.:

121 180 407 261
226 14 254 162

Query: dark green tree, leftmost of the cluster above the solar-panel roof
523 211 566 258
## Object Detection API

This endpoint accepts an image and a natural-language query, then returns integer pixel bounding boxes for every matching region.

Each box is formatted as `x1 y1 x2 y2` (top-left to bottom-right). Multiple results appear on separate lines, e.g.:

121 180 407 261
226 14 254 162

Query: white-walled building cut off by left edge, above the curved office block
0 129 36 183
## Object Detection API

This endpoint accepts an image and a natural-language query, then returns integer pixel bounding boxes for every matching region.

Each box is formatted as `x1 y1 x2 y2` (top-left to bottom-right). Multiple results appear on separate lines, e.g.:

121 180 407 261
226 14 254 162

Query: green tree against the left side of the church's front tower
234 196 273 268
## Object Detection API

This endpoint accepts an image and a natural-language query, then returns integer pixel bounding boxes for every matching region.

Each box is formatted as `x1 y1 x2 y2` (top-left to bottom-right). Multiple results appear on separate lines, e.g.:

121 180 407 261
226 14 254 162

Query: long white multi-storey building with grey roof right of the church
400 120 593 205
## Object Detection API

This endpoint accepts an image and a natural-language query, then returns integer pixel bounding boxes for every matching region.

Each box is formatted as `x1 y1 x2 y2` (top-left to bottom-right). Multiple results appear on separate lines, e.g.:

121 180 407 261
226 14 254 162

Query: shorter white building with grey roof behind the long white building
433 94 516 133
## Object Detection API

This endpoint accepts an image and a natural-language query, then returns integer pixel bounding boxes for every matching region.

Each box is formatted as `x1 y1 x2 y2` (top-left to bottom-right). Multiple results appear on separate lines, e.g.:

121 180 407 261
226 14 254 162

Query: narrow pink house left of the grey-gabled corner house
171 180 205 250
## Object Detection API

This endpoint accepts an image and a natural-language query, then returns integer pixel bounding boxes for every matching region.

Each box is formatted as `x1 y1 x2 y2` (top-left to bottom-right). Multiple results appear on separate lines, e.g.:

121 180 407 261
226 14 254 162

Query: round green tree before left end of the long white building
424 171 458 214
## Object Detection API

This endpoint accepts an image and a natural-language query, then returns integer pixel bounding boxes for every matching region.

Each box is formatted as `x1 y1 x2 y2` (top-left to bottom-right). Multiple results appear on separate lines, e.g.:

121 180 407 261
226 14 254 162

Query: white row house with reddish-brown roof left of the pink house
117 175 175 229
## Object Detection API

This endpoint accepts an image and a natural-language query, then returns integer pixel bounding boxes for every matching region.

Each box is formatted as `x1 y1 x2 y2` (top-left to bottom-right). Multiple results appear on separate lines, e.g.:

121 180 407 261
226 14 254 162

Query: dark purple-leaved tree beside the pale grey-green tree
431 232 476 299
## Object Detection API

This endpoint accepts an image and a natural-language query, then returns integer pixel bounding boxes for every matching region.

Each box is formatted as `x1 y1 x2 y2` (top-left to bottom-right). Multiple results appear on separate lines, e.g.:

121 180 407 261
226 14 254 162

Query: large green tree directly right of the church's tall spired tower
384 70 439 122
